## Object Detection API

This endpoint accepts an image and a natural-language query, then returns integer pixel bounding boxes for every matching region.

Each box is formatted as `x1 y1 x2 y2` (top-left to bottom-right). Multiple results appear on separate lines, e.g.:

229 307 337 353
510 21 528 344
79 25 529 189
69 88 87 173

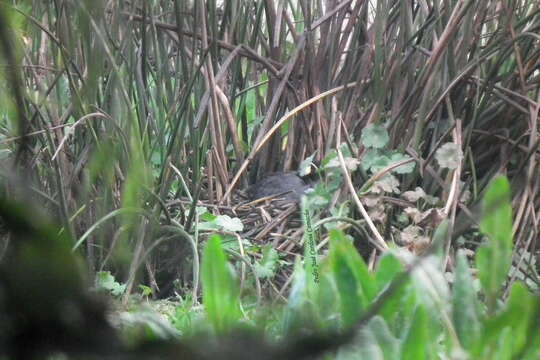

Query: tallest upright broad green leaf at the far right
476 177 512 311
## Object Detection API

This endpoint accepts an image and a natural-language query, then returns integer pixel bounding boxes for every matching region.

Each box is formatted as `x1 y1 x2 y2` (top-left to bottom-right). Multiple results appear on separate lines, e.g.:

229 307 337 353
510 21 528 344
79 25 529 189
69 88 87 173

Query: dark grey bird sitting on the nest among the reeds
248 172 310 202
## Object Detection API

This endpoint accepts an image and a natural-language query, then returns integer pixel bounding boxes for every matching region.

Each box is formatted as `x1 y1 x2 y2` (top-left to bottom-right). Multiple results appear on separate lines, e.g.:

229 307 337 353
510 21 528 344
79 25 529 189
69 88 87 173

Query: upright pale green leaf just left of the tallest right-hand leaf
452 252 480 349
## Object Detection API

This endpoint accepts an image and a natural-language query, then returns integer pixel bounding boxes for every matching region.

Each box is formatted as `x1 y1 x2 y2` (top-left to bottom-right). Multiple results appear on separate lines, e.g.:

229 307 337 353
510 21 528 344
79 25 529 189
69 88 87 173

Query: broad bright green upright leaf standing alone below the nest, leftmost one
202 235 240 333
